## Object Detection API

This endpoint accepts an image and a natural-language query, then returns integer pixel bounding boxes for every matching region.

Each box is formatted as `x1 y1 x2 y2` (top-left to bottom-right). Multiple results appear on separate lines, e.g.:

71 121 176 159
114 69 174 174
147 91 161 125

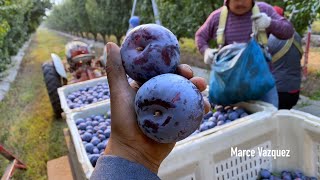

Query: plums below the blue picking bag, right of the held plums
192 105 249 135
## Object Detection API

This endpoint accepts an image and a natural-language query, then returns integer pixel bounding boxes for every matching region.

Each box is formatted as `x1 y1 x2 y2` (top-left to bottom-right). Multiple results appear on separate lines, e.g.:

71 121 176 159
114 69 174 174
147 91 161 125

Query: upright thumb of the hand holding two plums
106 42 130 101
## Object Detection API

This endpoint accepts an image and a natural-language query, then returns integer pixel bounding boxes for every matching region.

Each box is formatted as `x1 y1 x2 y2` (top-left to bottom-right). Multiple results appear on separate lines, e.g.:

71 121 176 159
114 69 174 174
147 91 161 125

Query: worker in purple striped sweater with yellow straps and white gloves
195 0 294 107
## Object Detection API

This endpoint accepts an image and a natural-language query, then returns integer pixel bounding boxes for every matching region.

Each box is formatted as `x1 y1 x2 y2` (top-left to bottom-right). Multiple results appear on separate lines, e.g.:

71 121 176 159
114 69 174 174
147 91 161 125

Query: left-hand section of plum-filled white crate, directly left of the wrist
66 102 111 179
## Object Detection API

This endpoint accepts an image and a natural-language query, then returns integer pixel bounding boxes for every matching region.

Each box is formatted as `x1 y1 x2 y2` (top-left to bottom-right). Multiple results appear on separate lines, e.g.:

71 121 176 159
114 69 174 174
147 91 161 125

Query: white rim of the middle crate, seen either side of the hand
67 102 275 178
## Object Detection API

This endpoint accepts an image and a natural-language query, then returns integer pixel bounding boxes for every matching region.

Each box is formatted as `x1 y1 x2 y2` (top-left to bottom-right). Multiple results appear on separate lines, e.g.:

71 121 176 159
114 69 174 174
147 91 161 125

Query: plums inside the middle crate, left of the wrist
75 111 111 166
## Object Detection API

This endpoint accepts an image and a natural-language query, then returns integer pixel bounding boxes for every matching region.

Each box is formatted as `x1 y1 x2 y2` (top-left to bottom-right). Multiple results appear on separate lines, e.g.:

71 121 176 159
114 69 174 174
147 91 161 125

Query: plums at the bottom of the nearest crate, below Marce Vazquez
258 169 318 180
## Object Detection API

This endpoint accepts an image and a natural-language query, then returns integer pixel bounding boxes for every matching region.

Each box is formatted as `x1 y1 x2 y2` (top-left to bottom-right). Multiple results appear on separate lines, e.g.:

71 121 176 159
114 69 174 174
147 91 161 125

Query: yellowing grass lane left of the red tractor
0 30 67 179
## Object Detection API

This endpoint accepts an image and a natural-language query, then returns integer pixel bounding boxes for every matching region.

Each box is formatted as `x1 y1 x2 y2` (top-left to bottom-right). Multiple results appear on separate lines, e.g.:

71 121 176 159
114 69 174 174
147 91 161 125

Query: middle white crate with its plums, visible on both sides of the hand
67 97 282 180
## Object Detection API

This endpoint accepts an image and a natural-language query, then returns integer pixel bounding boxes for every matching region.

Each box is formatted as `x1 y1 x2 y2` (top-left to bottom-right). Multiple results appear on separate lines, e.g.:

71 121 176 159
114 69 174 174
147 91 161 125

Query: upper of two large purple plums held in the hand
120 24 180 83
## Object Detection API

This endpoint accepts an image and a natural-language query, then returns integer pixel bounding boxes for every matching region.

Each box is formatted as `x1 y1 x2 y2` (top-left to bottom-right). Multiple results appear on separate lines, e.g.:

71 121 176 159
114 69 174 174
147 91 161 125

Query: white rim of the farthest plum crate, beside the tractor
58 76 110 114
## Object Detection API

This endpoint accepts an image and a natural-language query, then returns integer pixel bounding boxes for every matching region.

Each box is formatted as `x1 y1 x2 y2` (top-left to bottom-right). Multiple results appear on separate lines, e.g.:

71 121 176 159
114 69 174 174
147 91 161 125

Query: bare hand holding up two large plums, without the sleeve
105 43 210 174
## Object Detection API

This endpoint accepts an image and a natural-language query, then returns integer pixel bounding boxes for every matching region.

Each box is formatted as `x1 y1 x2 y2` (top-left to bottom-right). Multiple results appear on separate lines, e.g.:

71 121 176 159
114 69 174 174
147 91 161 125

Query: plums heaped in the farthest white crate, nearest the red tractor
67 82 110 109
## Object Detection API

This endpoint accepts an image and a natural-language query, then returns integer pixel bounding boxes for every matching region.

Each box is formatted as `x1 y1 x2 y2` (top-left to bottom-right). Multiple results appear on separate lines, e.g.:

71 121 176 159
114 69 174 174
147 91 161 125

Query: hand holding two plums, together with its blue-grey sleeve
90 43 210 180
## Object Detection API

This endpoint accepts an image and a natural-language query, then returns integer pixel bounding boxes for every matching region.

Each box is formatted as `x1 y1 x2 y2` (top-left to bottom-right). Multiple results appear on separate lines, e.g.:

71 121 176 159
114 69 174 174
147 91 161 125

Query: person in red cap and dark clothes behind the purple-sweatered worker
268 6 303 109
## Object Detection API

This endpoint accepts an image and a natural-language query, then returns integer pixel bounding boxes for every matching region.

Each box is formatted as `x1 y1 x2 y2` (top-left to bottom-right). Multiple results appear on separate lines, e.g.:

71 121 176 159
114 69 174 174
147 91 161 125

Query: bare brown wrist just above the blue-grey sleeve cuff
105 136 161 174
